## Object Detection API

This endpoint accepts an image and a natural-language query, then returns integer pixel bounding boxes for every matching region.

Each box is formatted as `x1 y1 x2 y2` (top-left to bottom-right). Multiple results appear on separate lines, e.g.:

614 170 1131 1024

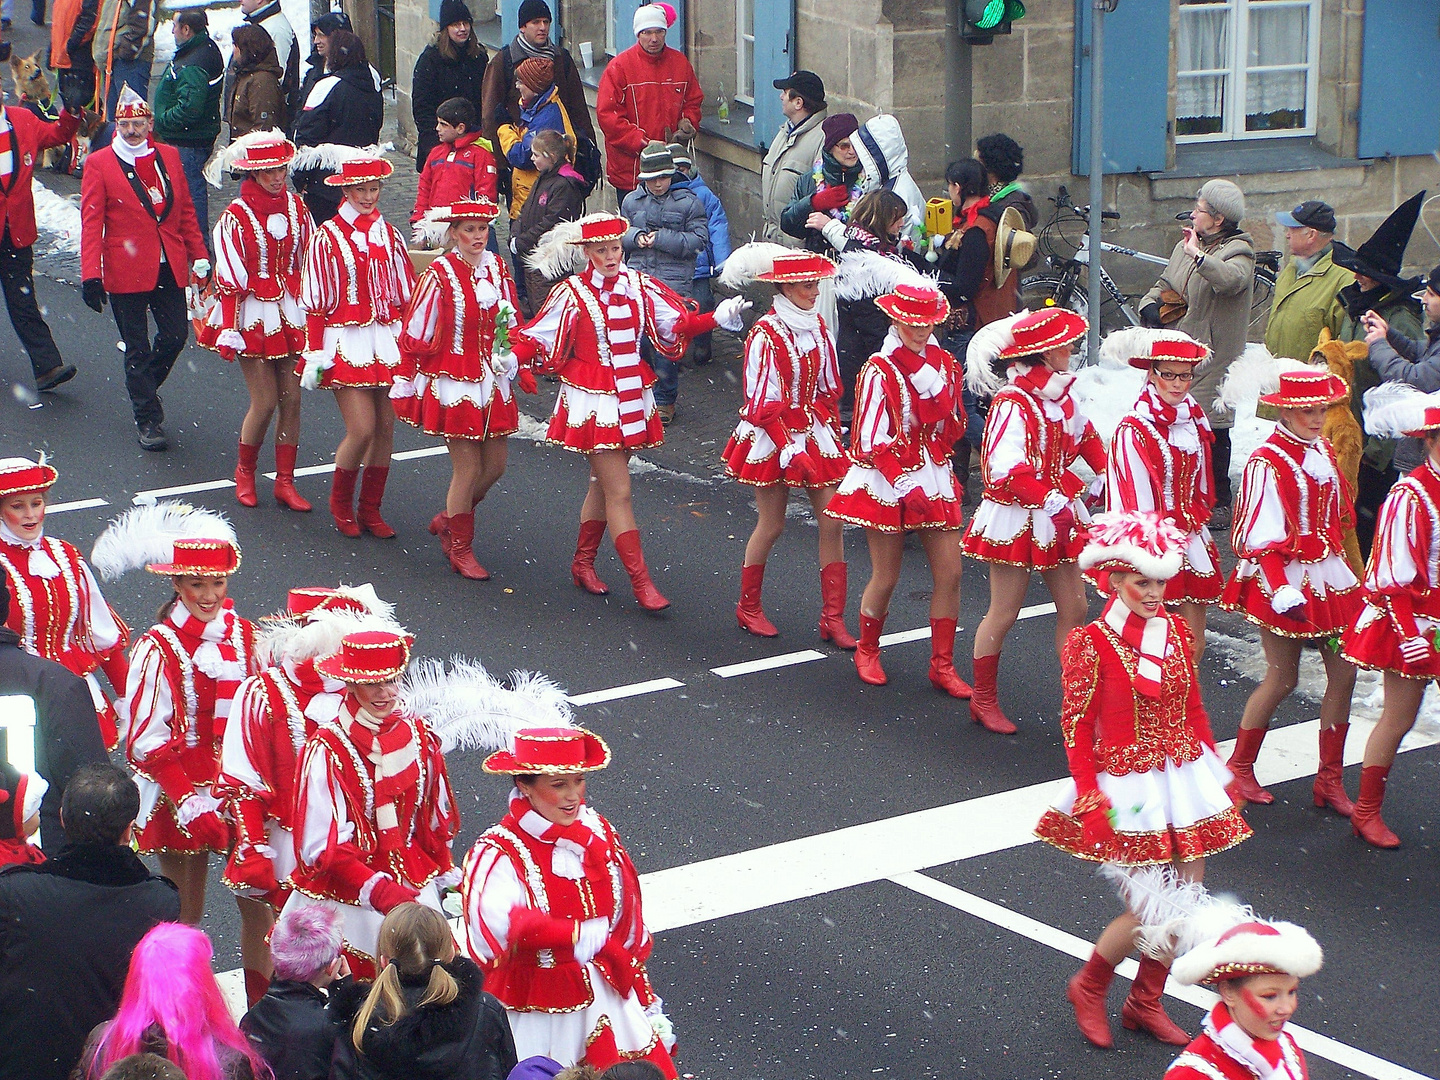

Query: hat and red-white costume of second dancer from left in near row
125 539 255 855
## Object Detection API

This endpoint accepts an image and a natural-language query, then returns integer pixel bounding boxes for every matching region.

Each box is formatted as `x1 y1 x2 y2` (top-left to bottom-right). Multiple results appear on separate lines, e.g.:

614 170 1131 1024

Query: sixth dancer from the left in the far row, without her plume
825 285 971 698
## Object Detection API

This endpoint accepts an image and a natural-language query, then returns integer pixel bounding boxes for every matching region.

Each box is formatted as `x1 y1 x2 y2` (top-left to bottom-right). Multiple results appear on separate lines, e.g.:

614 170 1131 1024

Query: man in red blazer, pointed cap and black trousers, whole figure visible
81 86 210 451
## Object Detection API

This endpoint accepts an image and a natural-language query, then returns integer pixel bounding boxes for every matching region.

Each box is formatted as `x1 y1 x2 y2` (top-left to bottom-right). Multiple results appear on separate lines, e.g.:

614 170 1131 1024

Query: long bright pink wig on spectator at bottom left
96 923 271 1080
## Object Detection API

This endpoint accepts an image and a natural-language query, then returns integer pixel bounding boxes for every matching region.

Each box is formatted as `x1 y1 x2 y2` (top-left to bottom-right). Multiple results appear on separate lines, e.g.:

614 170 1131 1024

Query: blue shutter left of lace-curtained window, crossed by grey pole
1071 0 1169 176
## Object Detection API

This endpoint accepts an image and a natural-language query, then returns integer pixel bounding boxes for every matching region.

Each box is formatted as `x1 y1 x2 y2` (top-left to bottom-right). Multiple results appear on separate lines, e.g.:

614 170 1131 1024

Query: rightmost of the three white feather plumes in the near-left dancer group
400 657 573 753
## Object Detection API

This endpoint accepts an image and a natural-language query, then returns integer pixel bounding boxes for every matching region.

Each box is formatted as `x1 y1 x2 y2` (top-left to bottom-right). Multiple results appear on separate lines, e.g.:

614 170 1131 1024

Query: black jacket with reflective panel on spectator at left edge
0 625 108 852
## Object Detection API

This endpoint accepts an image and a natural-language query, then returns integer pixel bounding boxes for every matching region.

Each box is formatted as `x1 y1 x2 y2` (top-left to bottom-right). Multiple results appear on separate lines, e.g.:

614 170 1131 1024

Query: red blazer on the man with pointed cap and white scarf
81 143 210 292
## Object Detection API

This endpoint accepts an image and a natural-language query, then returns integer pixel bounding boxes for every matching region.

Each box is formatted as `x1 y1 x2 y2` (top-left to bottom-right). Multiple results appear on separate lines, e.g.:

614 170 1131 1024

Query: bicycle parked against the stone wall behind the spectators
1020 186 1280 367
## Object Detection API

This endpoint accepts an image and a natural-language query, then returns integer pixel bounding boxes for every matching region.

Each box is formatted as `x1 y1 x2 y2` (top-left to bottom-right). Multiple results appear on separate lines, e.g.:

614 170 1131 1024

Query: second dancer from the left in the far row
300 148 415 540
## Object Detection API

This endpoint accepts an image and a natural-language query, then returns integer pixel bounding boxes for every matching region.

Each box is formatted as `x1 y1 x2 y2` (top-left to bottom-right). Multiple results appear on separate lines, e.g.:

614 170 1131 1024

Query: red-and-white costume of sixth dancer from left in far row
825 327 965 533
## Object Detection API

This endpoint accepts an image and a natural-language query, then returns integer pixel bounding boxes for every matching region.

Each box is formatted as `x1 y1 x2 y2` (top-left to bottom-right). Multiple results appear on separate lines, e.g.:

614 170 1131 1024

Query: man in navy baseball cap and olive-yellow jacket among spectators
1264 199 1355 360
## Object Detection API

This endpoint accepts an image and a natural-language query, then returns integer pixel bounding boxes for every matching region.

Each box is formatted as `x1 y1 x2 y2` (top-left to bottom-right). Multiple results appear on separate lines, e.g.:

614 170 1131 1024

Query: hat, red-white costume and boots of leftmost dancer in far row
196 131 314 511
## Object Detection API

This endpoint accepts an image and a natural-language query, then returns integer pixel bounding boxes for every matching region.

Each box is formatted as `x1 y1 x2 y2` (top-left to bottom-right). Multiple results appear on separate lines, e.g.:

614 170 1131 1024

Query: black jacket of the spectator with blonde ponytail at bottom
330 956 516 1080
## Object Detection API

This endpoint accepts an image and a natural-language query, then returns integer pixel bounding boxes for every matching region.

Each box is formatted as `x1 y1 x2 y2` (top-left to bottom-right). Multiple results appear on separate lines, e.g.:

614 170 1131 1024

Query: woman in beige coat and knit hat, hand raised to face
1140 180 1256 528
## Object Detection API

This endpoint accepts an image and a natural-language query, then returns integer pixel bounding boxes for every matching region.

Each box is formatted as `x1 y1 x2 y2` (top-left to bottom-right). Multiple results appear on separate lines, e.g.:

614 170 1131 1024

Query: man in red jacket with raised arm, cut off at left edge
0 88 81 393
